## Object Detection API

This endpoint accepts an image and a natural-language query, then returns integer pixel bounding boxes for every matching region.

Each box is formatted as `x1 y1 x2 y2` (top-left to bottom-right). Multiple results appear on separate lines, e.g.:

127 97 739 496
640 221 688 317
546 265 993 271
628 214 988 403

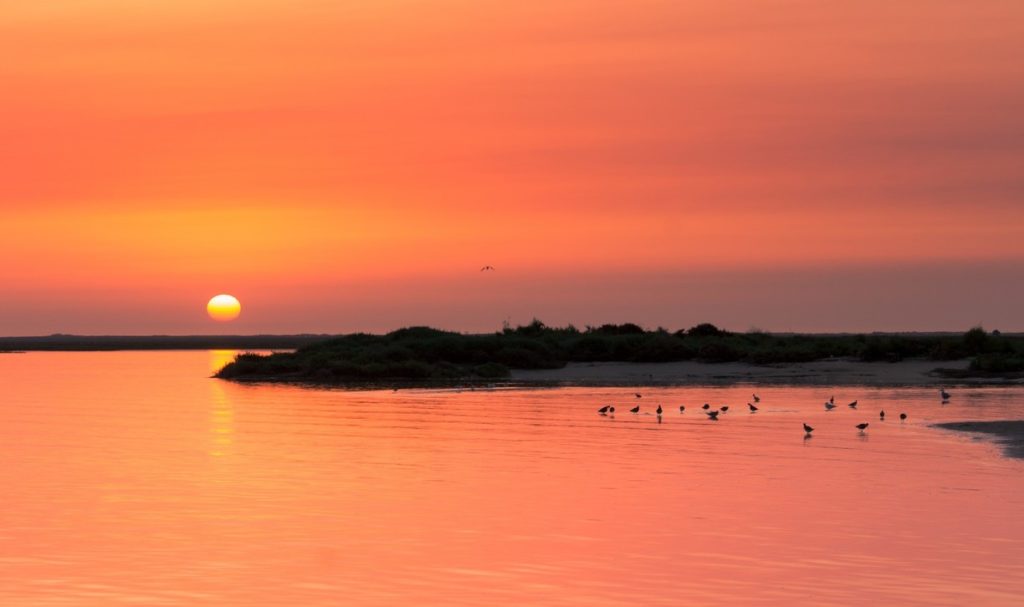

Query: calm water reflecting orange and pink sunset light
0 352 1024 606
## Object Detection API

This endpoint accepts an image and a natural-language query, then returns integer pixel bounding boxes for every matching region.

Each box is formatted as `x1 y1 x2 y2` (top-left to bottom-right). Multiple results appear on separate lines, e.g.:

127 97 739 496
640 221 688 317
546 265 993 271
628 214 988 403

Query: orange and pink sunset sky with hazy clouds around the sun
0 0 1024 335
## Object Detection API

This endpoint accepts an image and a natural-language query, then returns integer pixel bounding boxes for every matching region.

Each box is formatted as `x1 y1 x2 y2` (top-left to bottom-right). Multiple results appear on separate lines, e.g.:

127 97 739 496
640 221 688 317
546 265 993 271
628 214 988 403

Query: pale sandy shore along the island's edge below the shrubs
511 359 1010 386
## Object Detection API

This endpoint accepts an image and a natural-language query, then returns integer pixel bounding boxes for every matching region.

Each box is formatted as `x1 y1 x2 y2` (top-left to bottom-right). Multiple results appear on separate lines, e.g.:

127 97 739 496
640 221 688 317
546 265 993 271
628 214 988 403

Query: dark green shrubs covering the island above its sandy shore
216 319 1024 384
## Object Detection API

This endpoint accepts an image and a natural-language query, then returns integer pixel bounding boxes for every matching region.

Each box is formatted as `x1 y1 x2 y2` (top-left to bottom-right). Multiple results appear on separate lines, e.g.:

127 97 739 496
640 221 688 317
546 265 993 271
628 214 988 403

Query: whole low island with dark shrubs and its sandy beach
215 319 1024 385
